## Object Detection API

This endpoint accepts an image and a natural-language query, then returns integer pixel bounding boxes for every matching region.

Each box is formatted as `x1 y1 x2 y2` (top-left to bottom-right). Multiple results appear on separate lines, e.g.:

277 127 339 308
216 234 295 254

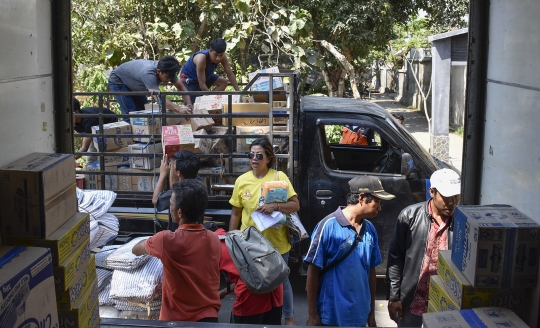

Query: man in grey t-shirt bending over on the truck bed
109 56 192 122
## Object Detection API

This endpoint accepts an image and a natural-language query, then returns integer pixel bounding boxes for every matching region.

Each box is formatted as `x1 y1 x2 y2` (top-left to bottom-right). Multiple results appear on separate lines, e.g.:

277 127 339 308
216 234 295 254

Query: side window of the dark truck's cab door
319 124 399 173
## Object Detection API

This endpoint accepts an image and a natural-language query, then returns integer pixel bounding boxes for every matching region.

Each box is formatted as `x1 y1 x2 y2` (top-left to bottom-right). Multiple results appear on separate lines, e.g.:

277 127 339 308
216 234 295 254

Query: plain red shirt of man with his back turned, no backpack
146 224 221 321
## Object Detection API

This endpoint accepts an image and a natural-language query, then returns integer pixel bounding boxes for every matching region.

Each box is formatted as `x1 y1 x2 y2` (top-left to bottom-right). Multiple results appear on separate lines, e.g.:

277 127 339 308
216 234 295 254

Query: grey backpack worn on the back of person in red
225 227 290 294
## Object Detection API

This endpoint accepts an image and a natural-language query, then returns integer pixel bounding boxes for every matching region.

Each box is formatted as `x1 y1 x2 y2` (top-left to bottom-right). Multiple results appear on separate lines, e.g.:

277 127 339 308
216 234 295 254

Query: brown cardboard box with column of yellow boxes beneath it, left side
0 153 99 328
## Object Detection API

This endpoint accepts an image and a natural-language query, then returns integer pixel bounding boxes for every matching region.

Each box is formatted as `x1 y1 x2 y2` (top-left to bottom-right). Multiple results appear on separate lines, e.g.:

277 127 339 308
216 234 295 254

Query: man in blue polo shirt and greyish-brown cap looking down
304 176 394 327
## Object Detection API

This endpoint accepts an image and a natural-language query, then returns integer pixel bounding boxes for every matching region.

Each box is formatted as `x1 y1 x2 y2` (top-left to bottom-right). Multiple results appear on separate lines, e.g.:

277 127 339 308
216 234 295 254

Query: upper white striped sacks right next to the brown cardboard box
77 188 119 249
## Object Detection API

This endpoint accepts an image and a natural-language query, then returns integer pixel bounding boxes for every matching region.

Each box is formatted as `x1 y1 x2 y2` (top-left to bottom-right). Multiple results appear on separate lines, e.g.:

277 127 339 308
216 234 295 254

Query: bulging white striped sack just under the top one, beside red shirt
105 256 163 303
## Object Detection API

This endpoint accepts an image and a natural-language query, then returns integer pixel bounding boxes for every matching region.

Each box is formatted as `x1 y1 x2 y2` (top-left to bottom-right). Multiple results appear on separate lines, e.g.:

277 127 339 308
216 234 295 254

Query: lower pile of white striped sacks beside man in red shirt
96 237 163 319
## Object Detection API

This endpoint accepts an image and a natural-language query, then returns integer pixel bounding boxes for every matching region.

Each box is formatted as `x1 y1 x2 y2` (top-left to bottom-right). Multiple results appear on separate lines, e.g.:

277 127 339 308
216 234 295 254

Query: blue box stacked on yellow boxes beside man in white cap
422 205 540 327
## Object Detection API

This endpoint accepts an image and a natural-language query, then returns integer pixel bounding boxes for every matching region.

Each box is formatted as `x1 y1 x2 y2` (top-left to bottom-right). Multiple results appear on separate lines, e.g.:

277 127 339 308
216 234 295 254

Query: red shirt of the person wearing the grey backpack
216 228 283 317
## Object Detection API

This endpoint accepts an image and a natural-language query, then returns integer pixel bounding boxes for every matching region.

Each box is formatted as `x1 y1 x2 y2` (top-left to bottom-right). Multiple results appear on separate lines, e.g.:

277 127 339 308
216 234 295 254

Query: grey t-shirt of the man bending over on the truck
109 59 178 91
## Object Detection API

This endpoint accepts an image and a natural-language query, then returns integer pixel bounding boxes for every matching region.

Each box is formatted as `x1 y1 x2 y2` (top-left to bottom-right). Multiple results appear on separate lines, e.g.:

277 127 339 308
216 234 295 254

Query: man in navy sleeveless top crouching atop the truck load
181 39 239 102
